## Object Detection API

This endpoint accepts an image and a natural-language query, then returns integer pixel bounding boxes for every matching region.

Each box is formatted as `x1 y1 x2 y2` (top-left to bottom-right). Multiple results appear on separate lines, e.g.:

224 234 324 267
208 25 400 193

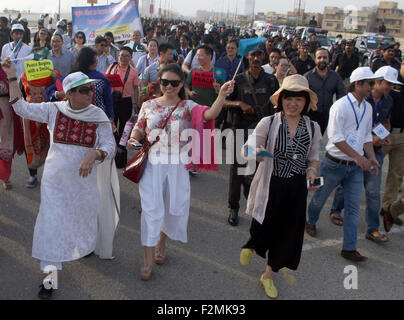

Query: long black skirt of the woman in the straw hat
243 175 307 272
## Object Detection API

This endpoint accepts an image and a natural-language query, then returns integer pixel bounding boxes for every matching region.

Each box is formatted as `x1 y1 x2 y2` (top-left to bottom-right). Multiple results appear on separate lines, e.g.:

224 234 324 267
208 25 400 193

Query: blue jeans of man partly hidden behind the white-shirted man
331 148 384 233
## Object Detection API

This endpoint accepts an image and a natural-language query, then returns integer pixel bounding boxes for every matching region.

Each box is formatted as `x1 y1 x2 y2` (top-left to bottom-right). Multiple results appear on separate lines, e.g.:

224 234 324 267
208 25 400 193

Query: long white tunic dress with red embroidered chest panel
13 99 115 262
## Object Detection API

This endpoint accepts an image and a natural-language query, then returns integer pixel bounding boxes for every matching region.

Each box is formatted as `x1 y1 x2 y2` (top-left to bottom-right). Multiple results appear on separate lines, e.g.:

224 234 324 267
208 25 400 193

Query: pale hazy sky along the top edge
0 0 404 16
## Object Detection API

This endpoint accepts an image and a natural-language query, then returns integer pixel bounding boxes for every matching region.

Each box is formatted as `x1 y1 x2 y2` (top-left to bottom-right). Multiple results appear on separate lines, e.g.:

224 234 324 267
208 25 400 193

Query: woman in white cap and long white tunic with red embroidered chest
2 60 115 298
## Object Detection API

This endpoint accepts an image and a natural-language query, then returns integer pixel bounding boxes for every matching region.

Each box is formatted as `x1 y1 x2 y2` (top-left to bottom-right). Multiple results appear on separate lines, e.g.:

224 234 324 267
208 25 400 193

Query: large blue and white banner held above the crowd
72 0 143 45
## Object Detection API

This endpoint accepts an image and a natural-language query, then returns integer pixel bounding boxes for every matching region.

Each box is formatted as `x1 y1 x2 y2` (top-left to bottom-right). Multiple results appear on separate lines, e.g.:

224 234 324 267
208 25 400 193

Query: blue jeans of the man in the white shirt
307 157 363 251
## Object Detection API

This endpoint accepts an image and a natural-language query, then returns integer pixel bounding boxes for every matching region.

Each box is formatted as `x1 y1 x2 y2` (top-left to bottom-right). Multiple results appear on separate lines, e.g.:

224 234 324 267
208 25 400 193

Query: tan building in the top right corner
374 1 404 36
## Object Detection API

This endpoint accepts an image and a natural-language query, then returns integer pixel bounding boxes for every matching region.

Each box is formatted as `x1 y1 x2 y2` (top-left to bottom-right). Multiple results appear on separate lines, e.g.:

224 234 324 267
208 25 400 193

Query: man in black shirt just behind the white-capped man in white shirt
331 41 359 89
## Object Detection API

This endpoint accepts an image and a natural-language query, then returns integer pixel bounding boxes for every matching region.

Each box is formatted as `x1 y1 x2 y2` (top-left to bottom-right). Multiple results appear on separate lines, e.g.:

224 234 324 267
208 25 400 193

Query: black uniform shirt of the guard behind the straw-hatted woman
228 69 279 129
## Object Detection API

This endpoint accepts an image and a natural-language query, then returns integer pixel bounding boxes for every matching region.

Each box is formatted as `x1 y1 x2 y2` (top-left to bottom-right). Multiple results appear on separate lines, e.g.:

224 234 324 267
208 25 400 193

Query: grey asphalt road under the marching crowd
0 146 404 300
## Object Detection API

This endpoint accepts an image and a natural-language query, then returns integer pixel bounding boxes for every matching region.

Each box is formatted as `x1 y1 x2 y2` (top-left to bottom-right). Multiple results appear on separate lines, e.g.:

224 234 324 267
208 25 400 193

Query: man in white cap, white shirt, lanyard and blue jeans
306 67 380 262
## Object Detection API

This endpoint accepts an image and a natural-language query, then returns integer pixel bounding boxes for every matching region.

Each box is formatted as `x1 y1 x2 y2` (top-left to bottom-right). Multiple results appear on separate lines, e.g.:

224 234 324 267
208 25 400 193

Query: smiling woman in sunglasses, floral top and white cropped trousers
127 64 234 280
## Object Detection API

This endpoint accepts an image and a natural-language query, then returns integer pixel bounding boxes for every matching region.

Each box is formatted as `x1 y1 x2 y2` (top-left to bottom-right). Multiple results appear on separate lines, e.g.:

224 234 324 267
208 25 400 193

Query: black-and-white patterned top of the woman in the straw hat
273 115 310 178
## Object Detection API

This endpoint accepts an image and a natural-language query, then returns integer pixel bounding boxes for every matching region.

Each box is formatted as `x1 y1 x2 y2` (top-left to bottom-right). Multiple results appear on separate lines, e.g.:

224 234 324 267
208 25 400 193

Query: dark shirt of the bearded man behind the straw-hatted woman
304 68 346 113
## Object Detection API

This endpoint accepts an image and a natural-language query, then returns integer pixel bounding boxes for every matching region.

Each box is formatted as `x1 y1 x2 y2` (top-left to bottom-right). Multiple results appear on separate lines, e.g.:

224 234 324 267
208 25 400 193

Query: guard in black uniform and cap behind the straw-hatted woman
225 49 279 226
